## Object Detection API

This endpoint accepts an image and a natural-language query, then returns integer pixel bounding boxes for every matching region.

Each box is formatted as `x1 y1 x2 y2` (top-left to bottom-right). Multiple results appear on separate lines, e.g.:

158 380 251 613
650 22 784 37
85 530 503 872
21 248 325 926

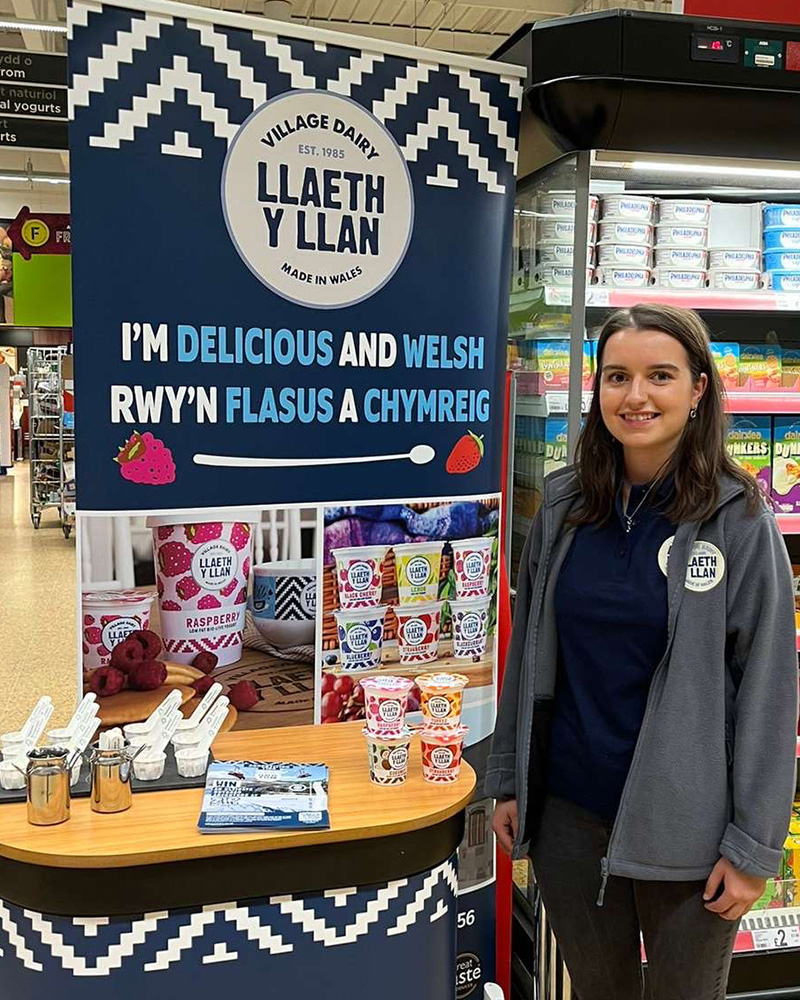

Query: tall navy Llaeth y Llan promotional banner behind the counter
70 0 524 997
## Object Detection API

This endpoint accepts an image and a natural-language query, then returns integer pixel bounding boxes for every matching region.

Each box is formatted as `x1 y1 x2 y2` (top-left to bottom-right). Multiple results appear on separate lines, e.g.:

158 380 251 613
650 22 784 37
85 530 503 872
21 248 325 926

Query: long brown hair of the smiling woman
574 305 761 524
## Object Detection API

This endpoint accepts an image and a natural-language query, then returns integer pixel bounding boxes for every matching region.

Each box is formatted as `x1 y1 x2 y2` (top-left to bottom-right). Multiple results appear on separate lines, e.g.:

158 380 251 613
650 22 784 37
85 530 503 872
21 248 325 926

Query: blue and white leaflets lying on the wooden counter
198 760 330 833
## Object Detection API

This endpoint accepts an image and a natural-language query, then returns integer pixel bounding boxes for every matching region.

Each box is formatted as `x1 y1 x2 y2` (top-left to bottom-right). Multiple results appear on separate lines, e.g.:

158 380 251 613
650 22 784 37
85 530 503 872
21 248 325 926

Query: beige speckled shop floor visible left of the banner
0 462 77 733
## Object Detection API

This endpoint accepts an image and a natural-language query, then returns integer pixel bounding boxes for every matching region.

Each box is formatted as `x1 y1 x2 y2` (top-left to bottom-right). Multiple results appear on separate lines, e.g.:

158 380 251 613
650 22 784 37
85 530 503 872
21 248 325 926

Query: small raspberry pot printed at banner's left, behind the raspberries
81 590 156 670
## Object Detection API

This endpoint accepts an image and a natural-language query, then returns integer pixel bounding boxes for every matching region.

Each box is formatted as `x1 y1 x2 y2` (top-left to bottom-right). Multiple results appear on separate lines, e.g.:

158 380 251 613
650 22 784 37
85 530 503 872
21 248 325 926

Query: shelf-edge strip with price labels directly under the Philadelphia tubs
544 285 800 312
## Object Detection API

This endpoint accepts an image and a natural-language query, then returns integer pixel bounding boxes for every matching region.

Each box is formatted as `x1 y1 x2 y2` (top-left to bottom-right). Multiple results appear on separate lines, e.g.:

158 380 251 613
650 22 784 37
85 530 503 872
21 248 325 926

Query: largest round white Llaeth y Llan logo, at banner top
222 90 414 309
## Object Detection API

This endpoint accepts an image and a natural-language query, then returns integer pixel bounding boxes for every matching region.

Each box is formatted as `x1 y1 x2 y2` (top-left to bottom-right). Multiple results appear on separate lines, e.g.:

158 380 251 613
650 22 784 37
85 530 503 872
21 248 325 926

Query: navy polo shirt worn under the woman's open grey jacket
548 482 675 820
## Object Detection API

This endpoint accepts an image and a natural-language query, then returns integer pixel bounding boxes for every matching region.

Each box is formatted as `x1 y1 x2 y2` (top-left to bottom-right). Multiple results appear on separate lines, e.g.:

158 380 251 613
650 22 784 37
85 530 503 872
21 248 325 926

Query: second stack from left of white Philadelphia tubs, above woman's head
596 194 655 288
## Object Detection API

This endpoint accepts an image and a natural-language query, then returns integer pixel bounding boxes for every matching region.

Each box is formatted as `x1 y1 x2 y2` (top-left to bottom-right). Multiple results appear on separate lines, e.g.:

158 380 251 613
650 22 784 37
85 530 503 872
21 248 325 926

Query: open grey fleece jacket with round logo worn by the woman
485 467 798 881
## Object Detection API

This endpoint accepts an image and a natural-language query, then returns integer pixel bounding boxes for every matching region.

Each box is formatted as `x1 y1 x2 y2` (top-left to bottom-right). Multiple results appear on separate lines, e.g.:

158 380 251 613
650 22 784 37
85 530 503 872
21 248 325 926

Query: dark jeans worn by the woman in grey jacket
531 796 738 1000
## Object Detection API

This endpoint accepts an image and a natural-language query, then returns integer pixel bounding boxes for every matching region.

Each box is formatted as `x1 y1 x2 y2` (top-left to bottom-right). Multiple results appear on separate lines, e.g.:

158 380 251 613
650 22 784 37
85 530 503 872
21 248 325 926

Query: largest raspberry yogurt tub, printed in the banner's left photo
147 511 255 667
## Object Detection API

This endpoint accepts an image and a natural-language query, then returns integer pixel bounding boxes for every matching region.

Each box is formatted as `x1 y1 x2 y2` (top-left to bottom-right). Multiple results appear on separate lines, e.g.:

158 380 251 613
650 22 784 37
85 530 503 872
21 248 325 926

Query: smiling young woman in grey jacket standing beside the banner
486 305 798 1000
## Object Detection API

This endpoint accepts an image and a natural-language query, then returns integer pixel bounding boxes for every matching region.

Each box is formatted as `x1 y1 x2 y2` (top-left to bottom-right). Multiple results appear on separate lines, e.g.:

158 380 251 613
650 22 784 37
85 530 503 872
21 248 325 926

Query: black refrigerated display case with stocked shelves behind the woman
495 11 800 1000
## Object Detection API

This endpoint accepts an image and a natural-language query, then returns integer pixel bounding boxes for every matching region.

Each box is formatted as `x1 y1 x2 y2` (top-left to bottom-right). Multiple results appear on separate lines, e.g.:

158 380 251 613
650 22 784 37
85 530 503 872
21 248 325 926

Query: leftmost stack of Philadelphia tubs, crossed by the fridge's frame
536 192 599 285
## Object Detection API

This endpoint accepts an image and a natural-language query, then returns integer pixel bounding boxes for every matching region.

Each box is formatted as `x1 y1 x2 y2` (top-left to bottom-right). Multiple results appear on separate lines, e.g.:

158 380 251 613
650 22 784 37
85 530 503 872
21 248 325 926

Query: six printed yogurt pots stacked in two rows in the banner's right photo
333 537 493 668
